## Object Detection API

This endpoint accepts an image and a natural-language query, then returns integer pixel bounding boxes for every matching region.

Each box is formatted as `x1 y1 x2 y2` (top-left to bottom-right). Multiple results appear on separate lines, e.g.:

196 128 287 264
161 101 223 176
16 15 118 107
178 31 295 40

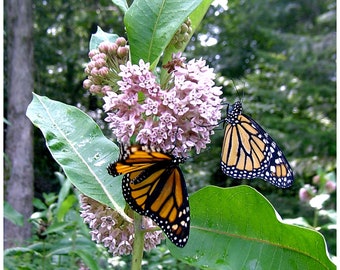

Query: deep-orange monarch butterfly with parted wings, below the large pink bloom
107 145 190 247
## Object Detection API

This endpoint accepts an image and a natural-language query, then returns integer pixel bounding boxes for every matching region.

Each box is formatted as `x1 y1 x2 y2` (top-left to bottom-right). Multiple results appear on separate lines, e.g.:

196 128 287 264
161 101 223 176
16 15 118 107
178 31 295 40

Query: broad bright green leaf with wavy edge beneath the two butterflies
168 186 335 270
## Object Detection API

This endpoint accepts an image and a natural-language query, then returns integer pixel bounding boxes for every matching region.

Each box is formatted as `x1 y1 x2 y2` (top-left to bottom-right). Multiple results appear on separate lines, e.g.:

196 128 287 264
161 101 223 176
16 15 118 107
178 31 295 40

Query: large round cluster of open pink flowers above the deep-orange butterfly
104 54 222 156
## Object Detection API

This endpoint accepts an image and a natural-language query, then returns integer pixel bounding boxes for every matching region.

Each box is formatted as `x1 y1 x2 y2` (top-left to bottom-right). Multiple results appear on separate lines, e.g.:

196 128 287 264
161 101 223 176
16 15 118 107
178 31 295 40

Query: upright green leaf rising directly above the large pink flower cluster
124 0 202 66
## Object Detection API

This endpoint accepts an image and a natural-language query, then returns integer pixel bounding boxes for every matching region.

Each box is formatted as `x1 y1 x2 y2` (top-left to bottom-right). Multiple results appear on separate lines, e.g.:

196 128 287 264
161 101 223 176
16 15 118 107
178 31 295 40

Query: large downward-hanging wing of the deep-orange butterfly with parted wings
122 160 190 247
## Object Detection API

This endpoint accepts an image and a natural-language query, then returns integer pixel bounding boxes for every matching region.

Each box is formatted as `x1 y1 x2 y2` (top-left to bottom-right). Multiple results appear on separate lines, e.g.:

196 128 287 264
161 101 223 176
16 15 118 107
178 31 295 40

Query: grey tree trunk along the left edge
4 0 34 248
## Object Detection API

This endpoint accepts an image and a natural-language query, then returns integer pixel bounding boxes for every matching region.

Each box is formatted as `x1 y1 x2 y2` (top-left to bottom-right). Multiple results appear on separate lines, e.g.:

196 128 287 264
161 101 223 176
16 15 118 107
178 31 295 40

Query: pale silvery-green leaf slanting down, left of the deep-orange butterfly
27 94 130 220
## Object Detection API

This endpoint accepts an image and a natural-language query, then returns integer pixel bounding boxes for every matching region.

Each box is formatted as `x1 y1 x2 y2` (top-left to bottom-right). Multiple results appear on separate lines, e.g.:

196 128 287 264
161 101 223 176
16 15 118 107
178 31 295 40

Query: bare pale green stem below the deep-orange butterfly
131 213 144 270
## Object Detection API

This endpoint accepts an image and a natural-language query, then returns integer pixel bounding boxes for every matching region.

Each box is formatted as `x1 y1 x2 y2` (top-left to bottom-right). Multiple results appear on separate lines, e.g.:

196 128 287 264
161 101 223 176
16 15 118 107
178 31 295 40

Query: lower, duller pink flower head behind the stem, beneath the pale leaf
80 195 165 256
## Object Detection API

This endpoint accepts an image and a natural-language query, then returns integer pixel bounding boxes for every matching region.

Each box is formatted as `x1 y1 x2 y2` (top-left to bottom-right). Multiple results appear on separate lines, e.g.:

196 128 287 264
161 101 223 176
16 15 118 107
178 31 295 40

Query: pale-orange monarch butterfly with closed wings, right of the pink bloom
221 101 294 188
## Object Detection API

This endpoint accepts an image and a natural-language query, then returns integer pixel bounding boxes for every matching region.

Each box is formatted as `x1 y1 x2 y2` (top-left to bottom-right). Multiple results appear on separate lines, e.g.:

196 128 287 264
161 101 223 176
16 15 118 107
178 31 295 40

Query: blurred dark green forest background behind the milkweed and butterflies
4 0 336 269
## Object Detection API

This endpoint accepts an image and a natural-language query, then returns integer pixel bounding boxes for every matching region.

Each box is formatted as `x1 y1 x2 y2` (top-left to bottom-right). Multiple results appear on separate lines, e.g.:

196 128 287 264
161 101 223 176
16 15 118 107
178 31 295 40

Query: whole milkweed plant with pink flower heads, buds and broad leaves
27 0 335 269
